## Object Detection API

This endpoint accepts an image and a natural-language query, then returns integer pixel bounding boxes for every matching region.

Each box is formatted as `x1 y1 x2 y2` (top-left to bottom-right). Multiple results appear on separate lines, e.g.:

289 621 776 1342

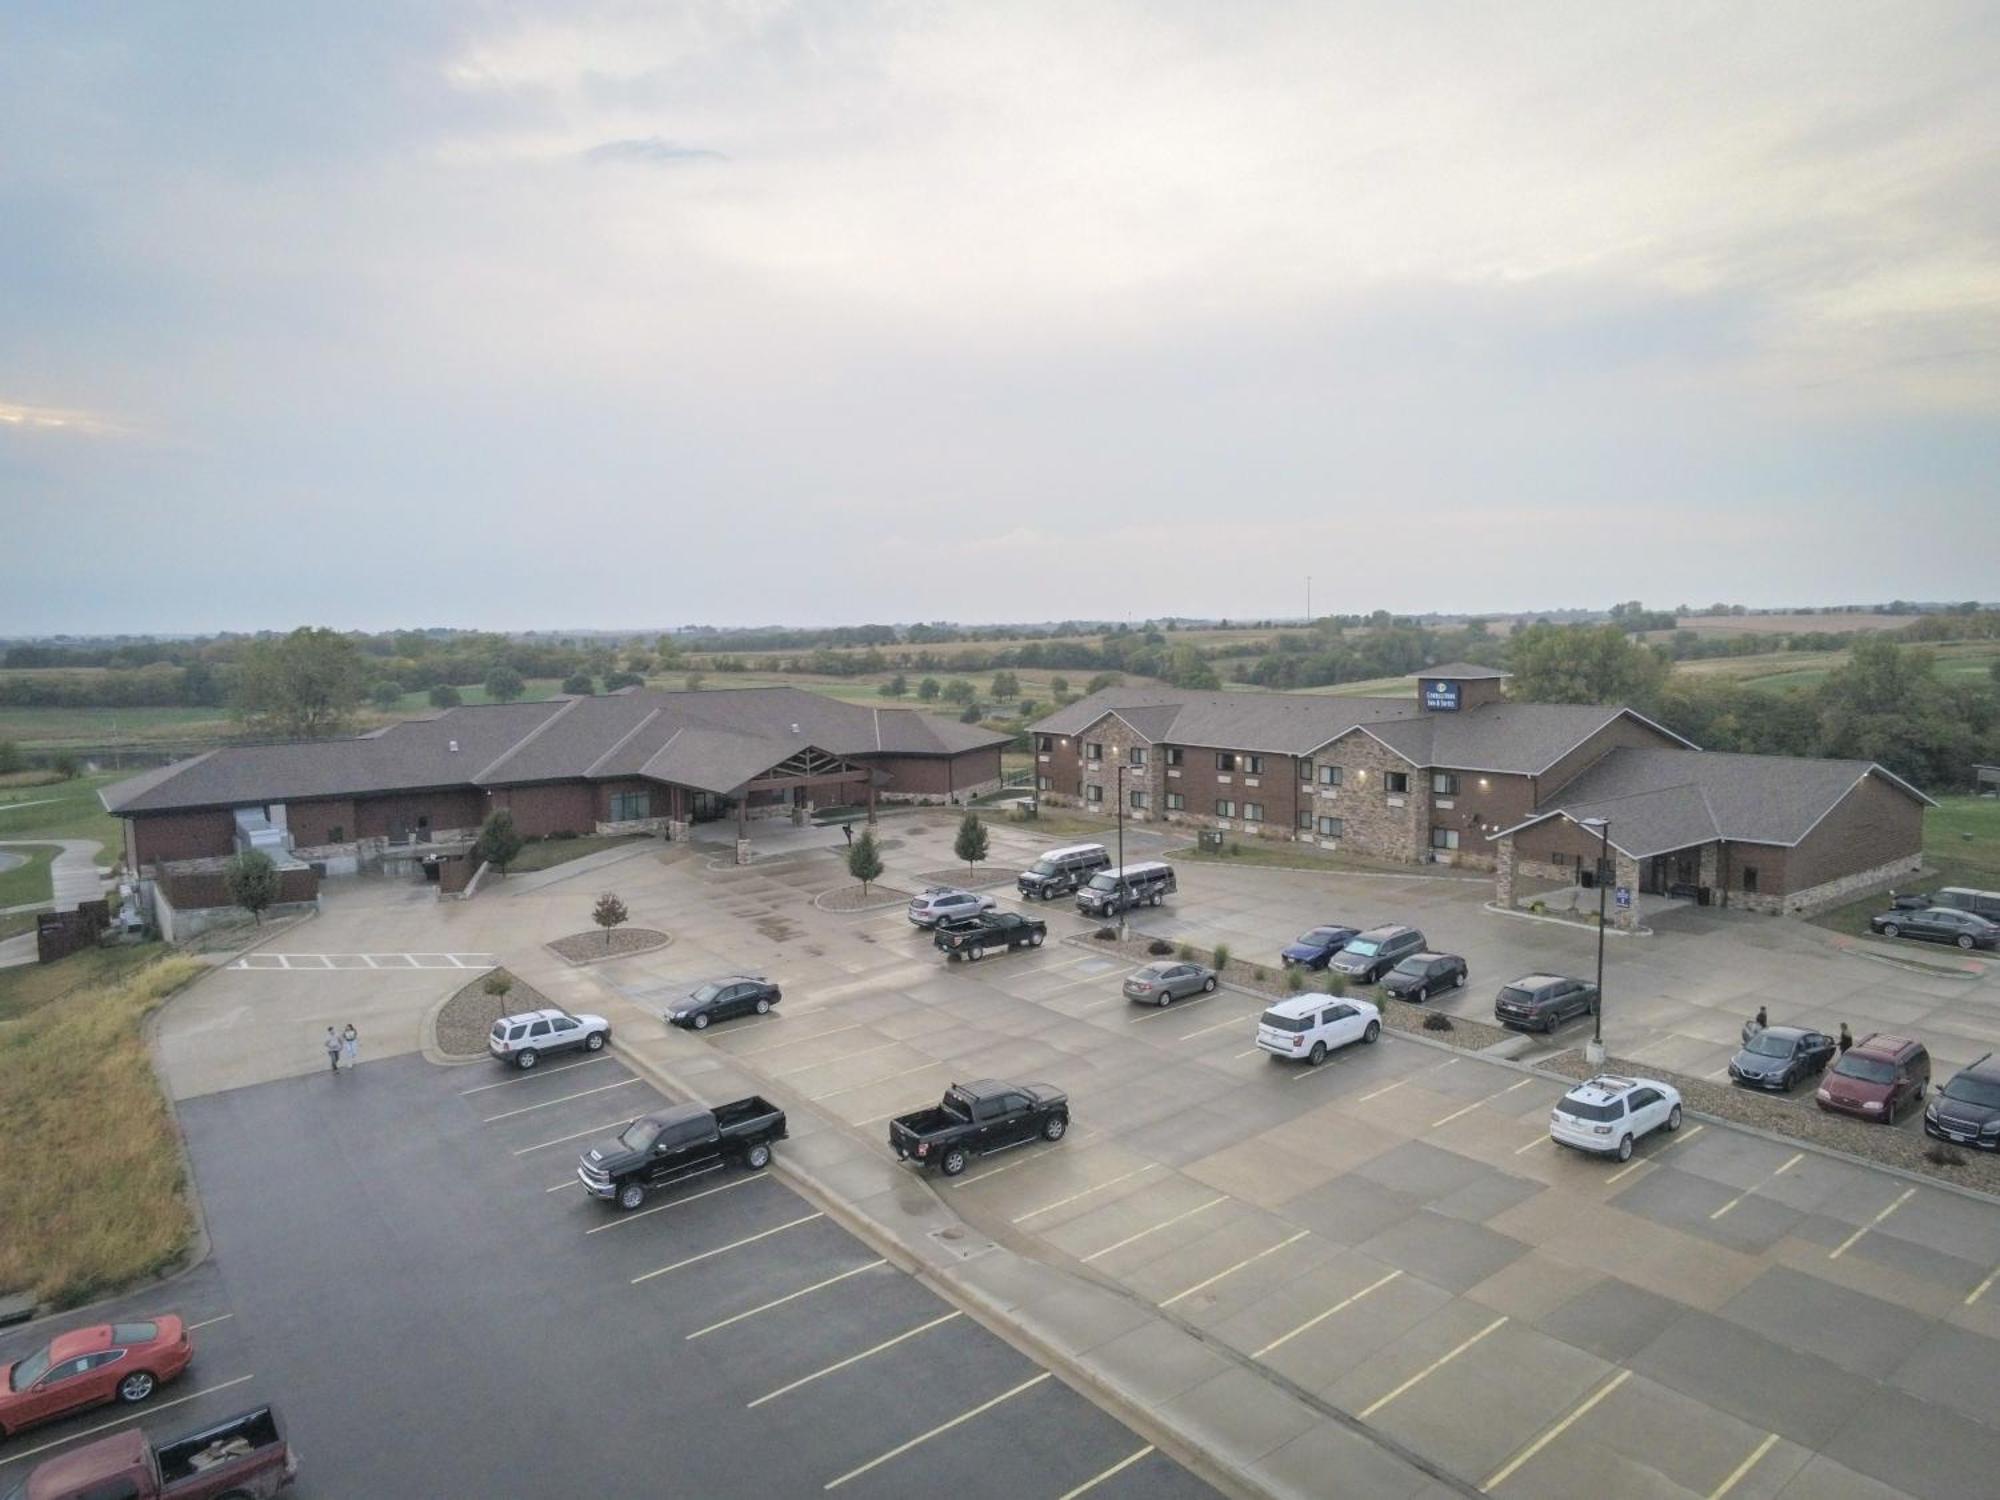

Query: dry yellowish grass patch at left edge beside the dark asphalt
0 944 202 1308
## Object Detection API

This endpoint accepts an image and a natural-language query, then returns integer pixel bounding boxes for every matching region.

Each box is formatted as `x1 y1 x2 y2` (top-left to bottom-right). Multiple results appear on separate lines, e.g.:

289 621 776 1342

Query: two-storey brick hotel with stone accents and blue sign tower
1032 662 1926 912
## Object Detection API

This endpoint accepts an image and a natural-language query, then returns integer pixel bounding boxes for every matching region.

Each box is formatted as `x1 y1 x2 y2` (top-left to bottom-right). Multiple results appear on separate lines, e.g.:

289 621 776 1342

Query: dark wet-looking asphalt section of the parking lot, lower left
0 1056 1212 1498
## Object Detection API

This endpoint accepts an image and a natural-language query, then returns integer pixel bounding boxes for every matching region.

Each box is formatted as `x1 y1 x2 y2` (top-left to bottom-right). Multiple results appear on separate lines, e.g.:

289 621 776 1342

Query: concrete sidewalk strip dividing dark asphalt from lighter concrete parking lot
516 962 1476 1500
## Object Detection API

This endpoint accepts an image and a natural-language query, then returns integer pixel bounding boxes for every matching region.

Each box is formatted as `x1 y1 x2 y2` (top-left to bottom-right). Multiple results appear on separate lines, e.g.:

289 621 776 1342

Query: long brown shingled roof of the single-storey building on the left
100 688 1008 812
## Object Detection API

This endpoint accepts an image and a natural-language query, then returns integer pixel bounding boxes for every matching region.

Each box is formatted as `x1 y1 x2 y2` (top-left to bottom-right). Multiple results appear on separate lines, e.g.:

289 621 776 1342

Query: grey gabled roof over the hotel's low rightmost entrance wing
1494 746 1930 858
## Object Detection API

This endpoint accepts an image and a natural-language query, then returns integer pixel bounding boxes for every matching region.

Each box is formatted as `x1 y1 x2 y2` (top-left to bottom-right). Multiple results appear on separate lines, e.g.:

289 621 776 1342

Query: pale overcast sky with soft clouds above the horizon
0 0 2000 634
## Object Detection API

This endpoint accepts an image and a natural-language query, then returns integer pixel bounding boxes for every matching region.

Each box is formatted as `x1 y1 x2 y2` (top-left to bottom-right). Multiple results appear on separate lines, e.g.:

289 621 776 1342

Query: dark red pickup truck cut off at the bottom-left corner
0 1406 298 1500
